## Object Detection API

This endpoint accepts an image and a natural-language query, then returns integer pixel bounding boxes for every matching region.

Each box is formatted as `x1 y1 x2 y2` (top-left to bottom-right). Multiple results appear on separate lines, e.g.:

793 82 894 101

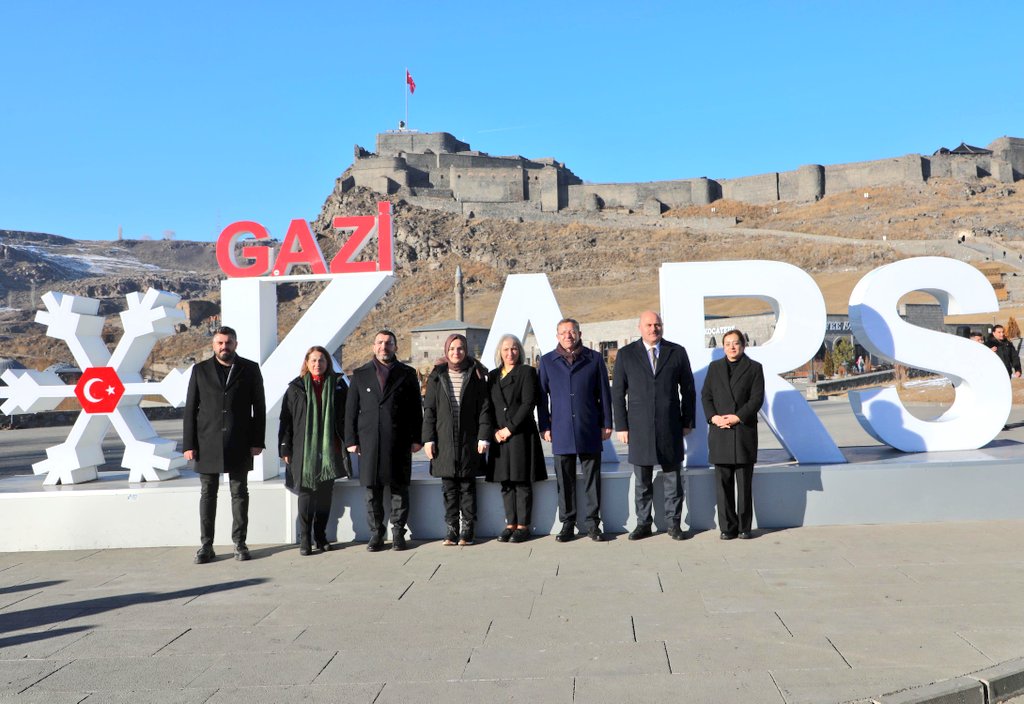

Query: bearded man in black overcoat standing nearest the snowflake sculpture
181 326 266 565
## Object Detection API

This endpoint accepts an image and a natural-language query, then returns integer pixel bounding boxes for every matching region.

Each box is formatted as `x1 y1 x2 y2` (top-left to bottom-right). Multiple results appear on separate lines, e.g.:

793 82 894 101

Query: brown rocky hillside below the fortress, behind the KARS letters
0 172 1024 373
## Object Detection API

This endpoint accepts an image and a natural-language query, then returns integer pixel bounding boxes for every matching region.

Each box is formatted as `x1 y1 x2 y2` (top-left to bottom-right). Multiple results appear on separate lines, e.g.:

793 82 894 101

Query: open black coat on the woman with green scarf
278 377 352 492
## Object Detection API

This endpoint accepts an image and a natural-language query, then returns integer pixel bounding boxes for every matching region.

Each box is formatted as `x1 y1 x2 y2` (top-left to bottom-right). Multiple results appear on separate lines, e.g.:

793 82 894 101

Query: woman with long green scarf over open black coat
278 346 351 555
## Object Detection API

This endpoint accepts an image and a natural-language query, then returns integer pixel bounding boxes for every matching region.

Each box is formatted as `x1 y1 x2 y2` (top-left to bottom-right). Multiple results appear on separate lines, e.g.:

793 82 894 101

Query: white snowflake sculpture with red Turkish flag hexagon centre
0 289 190 485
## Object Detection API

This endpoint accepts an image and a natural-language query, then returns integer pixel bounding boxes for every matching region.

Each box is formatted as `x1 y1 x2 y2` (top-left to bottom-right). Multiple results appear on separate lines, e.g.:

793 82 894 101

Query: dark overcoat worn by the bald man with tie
611 340 696 467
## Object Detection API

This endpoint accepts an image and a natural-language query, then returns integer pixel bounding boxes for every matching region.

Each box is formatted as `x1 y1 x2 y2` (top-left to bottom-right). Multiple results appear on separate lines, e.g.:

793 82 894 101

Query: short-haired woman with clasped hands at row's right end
700 329 765 540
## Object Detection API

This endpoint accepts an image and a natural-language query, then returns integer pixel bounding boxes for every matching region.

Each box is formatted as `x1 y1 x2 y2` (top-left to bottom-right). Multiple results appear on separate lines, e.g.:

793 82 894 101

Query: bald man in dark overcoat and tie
611 310 696 540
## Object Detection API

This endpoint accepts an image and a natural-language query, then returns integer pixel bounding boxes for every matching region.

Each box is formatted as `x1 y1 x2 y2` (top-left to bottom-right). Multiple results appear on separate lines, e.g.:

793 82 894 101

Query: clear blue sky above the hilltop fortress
0 0 1024 239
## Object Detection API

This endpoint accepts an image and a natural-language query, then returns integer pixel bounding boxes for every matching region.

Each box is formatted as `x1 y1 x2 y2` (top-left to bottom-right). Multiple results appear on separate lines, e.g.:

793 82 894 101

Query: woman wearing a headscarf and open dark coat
423 335 490 545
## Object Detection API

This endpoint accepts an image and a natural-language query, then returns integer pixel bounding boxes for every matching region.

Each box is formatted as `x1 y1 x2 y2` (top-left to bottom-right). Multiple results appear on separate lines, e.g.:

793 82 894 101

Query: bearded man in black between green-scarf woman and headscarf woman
345 329 423 553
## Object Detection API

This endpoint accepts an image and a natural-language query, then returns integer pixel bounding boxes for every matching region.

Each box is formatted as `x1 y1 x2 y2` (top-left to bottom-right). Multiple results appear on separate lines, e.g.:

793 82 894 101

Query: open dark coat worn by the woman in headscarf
423 362 494 479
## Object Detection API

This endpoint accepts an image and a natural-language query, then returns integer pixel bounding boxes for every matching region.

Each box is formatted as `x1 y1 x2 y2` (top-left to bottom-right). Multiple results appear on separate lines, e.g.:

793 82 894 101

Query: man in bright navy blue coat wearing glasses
537 318 611 542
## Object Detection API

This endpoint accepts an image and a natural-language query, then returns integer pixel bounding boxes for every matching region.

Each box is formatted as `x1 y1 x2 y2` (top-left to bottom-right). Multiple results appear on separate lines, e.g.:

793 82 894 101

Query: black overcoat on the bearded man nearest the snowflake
181 357 266 474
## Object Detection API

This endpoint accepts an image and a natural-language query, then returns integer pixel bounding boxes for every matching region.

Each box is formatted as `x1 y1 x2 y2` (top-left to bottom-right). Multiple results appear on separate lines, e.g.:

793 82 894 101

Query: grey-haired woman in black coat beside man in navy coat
487 335 548 542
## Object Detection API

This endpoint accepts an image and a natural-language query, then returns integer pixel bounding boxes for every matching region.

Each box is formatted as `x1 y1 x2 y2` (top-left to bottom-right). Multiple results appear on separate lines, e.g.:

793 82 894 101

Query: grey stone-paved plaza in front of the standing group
0 404 1024 704
